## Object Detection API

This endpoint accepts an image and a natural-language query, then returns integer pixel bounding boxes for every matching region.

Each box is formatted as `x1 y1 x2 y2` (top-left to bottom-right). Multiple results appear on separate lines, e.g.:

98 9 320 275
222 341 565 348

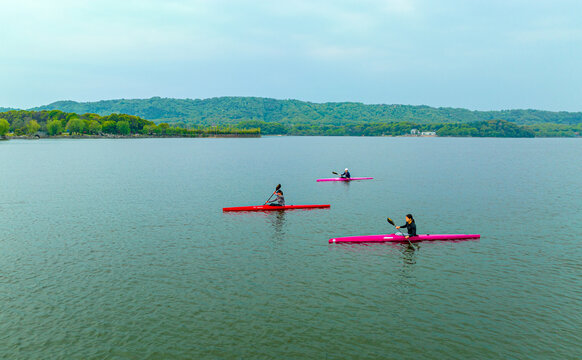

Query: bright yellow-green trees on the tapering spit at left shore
0 110 260 136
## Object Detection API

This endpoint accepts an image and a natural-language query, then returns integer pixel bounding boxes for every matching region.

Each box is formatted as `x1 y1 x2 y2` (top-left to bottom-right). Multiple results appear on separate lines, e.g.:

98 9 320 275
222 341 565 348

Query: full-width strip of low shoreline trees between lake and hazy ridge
0 110 582 139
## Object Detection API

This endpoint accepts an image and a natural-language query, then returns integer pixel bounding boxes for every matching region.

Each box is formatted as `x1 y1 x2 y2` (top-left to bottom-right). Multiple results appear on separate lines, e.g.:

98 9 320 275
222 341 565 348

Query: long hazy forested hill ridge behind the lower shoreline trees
30 97 582 125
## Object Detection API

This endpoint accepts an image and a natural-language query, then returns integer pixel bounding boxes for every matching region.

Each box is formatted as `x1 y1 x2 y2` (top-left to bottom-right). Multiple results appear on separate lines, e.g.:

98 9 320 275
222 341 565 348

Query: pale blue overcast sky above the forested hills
0 0 582 111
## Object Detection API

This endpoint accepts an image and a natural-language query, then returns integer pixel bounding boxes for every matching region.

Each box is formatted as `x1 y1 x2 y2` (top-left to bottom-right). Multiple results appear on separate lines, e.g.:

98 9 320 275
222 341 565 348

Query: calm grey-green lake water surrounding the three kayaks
0 137 582 359
